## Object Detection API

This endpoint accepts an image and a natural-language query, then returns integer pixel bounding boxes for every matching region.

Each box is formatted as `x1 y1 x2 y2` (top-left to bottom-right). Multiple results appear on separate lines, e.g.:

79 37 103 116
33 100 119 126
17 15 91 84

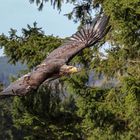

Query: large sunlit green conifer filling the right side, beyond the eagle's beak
60 0 140 140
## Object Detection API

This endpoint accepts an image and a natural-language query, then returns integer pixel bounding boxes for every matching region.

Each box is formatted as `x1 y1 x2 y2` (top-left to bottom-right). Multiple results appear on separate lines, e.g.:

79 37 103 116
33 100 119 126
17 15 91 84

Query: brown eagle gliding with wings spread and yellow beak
0 15 110 97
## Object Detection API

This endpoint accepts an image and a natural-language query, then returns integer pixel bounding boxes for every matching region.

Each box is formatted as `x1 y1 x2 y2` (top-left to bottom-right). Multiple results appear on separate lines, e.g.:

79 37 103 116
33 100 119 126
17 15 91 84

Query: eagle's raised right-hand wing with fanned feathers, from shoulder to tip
45 15 109 63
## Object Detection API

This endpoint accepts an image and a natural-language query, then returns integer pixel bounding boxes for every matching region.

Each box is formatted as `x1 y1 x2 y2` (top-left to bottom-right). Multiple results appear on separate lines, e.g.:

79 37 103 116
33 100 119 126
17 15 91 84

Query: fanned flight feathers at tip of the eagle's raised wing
70 15 110 46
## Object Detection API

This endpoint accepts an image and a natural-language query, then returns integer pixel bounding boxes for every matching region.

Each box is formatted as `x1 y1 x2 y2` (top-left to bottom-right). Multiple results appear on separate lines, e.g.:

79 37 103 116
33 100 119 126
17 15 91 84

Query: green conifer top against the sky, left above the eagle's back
0 23 61 69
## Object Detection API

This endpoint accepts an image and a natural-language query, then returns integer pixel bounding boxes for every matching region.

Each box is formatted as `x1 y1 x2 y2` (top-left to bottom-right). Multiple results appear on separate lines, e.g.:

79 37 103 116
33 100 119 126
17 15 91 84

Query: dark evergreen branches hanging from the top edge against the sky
29 0 100 24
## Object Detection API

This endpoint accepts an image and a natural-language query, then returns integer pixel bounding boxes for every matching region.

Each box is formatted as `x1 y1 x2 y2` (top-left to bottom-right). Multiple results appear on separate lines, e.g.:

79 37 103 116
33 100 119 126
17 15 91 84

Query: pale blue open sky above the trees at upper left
0 0 78 56
